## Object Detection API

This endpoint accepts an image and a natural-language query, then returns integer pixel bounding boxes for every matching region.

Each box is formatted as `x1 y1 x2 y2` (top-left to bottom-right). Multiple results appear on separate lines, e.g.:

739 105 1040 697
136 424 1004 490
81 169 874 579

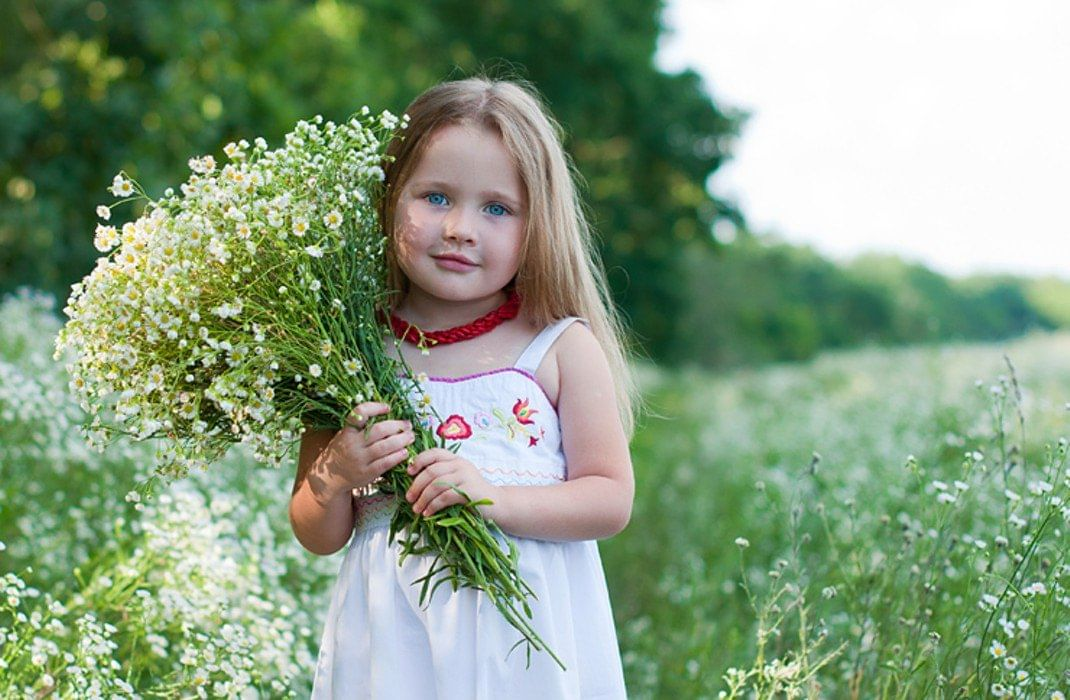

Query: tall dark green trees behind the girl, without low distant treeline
0 0 737 361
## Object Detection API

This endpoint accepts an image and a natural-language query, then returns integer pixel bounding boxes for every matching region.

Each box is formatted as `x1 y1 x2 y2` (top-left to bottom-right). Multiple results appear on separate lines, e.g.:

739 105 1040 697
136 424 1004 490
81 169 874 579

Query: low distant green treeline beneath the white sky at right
667 237 1070 366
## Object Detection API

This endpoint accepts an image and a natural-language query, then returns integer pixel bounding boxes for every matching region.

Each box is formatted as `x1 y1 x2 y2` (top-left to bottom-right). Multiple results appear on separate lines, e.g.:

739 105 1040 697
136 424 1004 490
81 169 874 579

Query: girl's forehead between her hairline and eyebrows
411 124 524 199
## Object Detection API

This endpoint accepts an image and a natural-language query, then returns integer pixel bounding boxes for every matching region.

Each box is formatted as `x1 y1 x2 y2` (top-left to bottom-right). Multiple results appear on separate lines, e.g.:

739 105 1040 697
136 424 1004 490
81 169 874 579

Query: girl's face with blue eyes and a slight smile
395 124 528 310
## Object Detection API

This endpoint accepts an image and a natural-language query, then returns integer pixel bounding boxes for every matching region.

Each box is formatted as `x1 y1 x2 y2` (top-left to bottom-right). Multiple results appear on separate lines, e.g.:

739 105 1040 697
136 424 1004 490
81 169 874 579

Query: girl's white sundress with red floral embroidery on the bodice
312 317 626 700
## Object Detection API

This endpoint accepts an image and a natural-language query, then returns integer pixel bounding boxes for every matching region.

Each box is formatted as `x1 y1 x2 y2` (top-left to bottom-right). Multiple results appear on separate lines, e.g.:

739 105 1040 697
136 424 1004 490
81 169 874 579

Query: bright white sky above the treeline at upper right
658 0 1070 278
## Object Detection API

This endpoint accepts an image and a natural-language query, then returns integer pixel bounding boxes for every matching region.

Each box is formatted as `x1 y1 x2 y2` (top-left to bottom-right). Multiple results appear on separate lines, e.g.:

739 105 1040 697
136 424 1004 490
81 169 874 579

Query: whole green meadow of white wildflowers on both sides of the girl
0 294 1070 698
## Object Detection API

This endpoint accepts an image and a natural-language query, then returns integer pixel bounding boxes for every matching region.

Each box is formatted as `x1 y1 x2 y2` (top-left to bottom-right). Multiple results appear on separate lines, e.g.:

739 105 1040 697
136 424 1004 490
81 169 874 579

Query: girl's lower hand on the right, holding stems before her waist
406 447 501 520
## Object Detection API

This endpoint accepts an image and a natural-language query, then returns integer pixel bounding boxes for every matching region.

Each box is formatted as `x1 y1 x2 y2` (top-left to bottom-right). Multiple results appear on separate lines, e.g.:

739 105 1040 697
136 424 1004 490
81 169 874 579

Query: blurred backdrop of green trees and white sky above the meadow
0 0 1070 367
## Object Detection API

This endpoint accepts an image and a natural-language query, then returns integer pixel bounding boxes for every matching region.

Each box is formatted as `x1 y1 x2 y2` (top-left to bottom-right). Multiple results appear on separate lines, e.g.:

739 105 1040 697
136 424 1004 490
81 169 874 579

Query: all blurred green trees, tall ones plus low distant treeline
0 0 1070 366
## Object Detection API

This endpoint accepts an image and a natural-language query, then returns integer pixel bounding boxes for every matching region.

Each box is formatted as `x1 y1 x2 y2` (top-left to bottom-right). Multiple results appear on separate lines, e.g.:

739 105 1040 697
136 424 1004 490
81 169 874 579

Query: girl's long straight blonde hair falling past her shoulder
379 76 639 438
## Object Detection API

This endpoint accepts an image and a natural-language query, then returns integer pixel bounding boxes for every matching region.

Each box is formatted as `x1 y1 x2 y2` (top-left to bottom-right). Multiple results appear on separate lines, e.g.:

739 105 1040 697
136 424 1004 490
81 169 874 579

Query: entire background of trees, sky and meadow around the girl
0 0 1070 700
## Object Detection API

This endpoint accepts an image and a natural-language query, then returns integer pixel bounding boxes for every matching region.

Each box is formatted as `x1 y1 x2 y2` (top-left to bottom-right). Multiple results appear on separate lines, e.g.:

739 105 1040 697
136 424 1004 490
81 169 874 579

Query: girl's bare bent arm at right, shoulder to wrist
487 323 636 541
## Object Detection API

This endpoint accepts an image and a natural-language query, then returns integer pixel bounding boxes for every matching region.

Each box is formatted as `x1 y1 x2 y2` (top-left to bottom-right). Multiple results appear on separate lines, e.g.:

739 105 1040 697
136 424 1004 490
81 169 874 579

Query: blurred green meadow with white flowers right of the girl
602 335 1070 698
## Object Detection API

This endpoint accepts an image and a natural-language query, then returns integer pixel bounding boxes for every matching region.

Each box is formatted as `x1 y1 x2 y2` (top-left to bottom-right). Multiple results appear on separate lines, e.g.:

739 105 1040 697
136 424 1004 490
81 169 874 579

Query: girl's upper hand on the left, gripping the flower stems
328 401 416 496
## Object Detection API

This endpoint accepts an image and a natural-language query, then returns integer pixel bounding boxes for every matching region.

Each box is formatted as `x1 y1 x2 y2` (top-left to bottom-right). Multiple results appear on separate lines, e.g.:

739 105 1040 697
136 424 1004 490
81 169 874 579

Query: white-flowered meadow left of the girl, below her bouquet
0 294 337 698
